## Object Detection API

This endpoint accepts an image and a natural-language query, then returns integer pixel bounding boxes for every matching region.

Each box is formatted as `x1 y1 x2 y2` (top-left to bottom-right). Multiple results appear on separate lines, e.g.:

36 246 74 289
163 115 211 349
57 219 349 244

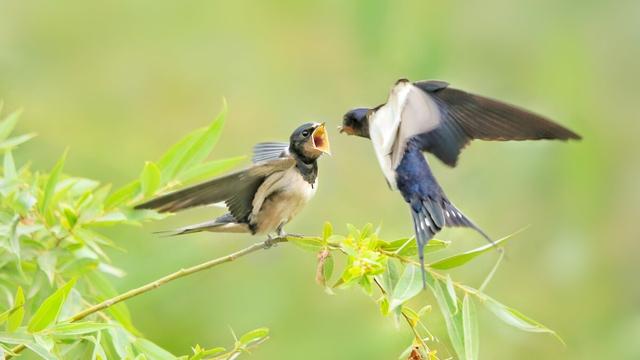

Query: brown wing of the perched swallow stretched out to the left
135 157 295 221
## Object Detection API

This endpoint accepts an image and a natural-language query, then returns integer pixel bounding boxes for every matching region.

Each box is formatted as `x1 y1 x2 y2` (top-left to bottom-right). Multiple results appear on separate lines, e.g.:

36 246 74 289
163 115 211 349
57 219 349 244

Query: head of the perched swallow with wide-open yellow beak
289 123 331 160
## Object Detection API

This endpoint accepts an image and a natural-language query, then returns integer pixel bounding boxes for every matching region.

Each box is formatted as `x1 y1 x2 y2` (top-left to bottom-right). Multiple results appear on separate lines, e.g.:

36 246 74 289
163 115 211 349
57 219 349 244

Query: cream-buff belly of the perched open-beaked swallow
251 173 316 234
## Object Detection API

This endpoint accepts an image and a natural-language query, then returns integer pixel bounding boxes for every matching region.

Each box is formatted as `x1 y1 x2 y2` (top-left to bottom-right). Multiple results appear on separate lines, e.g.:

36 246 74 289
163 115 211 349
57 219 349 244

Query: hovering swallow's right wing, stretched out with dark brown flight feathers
408 81 580 166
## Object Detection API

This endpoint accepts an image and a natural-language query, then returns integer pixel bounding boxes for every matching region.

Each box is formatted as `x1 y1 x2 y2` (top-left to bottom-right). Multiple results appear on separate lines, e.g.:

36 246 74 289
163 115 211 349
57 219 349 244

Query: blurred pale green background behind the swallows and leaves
0 0 640 359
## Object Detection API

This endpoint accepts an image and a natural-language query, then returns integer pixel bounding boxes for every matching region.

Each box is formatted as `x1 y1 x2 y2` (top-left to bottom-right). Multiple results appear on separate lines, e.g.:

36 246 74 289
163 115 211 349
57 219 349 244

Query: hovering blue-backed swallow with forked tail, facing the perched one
340 79 580 283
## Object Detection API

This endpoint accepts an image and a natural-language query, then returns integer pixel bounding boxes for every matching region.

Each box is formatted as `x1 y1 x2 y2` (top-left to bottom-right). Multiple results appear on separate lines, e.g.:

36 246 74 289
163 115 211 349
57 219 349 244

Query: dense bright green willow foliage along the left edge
0 107 267 359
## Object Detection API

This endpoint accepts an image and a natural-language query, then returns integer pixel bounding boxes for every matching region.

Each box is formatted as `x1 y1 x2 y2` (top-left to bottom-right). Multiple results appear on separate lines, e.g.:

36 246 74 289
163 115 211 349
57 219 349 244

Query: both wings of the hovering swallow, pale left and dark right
369 80 580 189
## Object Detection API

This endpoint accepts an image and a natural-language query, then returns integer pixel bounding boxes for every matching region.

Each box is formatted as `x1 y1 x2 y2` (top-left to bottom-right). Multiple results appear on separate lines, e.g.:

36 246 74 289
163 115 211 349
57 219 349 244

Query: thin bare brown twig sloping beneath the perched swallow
5 237 287 360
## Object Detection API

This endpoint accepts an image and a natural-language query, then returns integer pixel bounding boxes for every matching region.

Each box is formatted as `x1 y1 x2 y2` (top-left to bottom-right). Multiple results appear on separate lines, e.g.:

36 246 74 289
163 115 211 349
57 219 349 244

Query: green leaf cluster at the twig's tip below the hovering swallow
287 223 562 359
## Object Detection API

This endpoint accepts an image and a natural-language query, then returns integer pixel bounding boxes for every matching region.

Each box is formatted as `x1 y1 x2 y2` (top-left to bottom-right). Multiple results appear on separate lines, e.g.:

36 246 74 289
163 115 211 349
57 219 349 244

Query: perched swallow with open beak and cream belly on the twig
135 123 330 238
